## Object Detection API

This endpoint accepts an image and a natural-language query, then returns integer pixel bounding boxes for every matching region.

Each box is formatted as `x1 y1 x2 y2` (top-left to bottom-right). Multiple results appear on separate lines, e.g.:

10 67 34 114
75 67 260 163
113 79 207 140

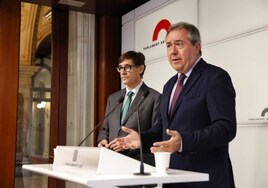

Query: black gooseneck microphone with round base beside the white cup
134 90 150 176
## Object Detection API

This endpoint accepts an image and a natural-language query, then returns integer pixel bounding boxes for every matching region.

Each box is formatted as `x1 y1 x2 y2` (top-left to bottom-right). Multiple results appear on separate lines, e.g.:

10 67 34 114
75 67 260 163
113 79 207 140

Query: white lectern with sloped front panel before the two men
22 146 209 188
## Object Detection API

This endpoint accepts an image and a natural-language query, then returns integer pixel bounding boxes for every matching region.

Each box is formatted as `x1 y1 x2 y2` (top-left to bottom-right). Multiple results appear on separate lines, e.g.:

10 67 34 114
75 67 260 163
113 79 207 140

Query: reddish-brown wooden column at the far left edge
0 0 20 187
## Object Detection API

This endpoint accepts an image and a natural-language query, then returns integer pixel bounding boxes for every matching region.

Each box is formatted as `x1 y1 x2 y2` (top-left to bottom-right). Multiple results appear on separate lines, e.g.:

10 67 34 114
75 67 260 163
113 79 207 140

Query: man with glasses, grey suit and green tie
98 51 161 165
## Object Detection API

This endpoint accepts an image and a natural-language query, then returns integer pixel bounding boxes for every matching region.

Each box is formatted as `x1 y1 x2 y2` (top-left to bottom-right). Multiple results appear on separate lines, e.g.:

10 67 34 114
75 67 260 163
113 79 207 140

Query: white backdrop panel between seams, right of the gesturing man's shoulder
203 30 268 124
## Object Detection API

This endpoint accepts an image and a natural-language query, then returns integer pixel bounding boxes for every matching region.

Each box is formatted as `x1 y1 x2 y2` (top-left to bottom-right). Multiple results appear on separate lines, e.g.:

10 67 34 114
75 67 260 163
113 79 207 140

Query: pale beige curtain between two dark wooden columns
67 11 95 146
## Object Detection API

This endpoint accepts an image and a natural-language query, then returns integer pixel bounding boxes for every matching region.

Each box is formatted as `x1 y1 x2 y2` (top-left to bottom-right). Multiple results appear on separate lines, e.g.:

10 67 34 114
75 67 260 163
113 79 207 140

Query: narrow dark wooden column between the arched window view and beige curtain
49 9 69 188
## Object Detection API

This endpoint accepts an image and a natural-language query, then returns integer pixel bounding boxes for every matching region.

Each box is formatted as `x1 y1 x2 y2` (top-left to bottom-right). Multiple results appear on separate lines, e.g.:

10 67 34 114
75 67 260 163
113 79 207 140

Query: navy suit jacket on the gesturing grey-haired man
142 59 236 188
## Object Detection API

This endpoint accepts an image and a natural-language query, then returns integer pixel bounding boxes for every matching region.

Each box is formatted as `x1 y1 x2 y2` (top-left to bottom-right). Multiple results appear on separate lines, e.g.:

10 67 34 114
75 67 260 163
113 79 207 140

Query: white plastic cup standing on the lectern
154 152 170 176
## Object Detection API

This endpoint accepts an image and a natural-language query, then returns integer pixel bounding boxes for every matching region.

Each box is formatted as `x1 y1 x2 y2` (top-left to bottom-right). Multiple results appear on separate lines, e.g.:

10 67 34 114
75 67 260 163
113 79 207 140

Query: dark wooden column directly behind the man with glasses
95 16 121 145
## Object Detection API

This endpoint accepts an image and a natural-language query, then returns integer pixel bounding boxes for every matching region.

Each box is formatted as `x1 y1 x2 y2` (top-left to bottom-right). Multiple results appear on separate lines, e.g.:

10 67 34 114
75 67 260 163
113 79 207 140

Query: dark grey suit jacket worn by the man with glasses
98 83 161 165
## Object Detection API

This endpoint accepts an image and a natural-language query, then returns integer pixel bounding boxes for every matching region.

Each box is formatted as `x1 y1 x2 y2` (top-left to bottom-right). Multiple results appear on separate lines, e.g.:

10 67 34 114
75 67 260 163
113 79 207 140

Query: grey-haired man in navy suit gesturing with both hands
114 22 236 188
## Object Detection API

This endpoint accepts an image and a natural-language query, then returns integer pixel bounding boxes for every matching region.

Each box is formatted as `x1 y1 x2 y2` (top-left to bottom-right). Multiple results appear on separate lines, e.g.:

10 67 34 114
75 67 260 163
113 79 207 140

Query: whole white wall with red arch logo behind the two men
122 0 268 188
